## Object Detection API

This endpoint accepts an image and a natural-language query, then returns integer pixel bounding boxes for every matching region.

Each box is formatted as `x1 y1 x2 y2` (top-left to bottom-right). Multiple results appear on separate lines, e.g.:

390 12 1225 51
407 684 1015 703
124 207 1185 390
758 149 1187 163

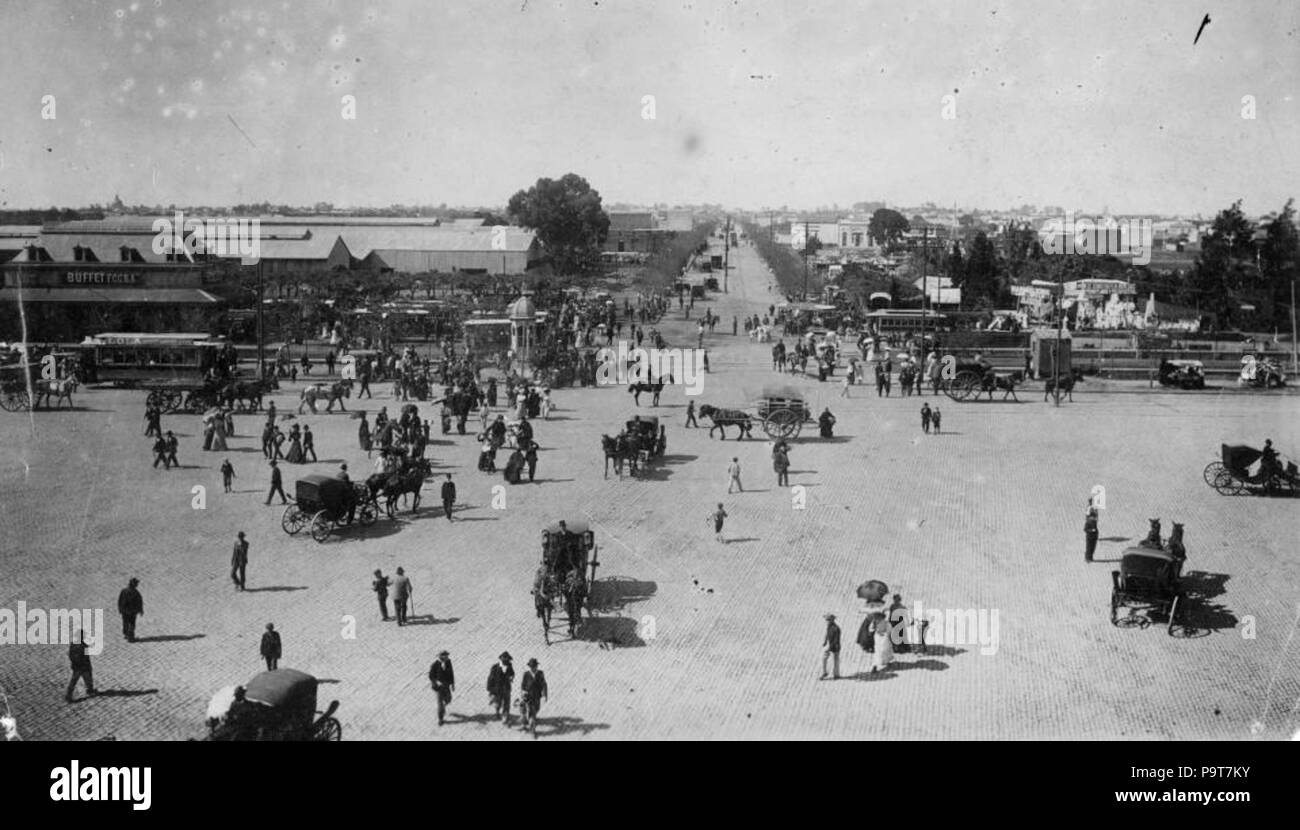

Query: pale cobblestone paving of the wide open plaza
0 239 1300 740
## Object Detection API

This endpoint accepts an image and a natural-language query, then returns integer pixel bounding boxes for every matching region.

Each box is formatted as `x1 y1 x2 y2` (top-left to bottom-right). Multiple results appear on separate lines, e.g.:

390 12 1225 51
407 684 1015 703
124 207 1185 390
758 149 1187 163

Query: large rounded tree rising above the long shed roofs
506 173 610 274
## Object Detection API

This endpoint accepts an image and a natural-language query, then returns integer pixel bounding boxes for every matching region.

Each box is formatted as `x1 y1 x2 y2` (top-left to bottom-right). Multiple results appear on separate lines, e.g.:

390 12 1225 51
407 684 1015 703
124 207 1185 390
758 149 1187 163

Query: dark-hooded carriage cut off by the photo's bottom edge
207 669 343 742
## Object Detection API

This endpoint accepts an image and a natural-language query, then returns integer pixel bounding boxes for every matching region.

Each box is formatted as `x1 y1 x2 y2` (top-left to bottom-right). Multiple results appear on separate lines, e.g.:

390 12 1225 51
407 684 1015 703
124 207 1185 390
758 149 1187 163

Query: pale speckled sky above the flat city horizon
0 0 1300 216
